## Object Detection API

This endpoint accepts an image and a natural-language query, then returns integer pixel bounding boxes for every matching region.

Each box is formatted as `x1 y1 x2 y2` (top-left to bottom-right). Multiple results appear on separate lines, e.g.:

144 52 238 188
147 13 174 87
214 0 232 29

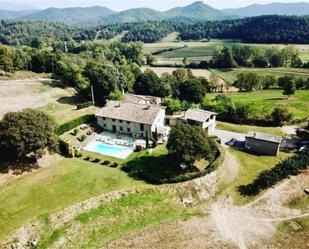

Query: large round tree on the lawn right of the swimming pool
167 124 218 165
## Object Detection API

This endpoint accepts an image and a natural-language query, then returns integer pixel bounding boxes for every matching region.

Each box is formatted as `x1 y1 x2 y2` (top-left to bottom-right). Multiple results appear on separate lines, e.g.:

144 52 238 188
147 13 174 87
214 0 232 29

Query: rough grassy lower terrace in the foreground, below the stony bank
37 190 201 249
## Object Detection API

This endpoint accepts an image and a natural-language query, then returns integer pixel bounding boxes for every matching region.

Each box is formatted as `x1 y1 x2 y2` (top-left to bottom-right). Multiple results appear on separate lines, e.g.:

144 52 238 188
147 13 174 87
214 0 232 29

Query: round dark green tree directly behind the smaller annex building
179 78 206 104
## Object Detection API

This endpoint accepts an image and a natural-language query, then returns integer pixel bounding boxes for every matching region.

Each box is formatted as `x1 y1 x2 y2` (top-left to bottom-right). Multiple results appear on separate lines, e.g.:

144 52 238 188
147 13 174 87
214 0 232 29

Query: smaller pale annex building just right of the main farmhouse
165 109 217 131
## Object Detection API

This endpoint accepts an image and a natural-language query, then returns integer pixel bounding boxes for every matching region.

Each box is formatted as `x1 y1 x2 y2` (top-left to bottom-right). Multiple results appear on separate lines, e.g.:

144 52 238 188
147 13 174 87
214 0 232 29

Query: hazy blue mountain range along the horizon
0 1 309 25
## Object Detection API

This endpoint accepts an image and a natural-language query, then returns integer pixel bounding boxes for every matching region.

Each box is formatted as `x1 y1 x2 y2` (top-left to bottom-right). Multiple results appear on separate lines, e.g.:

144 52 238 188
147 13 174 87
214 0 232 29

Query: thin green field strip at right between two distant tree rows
211 68 309 84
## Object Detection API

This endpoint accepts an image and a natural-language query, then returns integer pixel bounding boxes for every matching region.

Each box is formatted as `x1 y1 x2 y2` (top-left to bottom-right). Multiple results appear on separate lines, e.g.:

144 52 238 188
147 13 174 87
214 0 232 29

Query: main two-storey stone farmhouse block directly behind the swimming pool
96 101 168 138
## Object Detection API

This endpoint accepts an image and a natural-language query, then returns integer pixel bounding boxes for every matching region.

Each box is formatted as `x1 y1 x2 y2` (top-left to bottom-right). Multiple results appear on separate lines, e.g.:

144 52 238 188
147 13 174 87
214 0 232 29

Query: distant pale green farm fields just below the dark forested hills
144 38 309 64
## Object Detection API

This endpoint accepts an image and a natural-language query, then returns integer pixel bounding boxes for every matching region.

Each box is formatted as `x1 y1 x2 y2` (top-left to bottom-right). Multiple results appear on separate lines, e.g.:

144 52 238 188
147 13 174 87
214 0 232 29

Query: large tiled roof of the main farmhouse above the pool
96 101 162 125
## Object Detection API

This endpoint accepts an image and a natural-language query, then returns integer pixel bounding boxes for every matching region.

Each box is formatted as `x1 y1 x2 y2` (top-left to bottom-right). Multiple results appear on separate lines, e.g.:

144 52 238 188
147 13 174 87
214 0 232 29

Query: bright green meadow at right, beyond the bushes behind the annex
207 90 309 120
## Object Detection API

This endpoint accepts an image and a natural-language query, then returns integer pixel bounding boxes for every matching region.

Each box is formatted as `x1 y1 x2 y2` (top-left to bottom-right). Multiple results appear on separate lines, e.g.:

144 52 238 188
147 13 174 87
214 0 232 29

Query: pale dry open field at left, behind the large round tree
0 79 97 124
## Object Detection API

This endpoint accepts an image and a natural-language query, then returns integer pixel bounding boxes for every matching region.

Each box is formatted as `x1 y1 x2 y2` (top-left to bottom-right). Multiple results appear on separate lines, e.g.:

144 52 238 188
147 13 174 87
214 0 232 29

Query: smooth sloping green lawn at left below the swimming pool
0 159 145 239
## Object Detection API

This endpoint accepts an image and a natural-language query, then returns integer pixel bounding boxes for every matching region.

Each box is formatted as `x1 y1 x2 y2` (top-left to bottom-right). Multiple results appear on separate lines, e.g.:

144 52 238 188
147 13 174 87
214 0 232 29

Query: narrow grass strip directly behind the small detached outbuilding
217 121 285 136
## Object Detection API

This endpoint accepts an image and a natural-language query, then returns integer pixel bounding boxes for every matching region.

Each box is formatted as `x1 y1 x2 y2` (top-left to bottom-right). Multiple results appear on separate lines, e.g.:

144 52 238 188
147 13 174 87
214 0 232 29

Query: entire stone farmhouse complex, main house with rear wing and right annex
96 94 217 139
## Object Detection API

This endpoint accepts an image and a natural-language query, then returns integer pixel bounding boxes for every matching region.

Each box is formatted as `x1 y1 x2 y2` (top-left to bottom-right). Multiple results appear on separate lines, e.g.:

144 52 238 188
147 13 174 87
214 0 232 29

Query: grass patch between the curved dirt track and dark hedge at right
220 149 289 205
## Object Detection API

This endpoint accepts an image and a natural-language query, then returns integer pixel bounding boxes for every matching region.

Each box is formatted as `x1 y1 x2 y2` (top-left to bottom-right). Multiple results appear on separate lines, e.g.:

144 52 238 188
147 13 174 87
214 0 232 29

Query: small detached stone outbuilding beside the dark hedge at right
246 131 282 156
